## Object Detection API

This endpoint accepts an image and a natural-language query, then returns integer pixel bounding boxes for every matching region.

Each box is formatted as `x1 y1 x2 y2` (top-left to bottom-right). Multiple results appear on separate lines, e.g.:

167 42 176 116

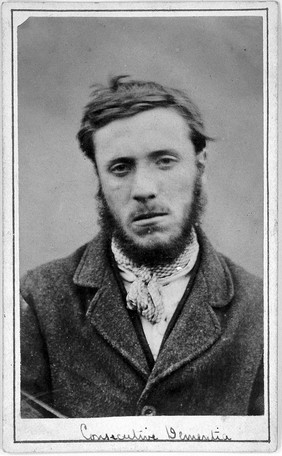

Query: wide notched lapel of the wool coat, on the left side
73 234 150 379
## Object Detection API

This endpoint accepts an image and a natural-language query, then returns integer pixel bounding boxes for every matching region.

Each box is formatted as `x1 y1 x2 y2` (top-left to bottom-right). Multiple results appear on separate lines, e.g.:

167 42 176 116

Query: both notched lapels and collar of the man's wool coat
73 230 234 382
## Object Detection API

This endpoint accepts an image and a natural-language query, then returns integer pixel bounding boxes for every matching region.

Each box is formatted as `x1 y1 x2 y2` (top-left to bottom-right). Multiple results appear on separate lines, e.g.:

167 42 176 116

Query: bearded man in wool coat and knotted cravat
21 76 264 417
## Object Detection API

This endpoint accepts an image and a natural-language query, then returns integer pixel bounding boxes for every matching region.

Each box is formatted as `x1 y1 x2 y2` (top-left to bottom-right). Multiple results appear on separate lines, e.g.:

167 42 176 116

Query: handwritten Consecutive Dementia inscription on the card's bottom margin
80 423 232 442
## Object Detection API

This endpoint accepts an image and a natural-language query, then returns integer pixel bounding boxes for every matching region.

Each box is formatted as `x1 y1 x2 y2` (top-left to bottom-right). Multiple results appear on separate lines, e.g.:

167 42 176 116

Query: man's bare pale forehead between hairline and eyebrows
94 108 191 153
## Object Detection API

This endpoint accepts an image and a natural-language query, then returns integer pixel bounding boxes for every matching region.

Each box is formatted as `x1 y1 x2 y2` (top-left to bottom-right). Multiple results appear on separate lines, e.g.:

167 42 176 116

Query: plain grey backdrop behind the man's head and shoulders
18 16 263 276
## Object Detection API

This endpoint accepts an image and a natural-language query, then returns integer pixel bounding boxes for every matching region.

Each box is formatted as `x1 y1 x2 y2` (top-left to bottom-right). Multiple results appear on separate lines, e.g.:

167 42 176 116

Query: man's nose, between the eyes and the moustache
131 166 157 202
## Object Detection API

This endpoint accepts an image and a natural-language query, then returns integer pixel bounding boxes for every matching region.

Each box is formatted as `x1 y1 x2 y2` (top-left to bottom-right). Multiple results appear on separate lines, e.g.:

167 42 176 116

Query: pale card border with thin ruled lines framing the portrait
3 1 278 451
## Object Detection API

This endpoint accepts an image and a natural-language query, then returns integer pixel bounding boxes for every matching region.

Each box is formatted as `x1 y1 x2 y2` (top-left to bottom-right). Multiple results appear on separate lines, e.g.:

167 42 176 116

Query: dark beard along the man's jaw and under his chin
96 173 206 268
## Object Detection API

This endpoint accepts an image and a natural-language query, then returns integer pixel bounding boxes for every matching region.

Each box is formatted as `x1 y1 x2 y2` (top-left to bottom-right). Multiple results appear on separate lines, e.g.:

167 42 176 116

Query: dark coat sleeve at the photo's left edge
20 296 52 418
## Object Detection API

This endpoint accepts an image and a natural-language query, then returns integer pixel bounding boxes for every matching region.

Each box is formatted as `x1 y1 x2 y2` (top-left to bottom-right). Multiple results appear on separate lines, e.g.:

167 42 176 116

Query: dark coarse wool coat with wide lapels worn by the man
21 233 263 417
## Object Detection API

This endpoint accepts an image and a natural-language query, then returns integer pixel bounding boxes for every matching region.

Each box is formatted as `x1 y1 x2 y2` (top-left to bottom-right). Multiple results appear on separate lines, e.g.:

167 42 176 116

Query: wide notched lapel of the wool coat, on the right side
150 232 234 382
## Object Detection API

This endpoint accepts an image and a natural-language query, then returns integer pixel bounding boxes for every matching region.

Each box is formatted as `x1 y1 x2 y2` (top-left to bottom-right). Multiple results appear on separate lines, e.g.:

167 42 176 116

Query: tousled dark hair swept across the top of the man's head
77 76 212 164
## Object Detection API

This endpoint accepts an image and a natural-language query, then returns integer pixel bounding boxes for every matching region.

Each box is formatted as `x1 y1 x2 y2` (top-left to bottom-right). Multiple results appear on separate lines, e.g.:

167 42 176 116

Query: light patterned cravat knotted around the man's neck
111 229 199 324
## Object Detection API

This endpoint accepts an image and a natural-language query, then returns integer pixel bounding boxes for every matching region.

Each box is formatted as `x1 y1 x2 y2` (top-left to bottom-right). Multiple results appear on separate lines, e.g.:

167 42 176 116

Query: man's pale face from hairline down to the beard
95 108 203 262
